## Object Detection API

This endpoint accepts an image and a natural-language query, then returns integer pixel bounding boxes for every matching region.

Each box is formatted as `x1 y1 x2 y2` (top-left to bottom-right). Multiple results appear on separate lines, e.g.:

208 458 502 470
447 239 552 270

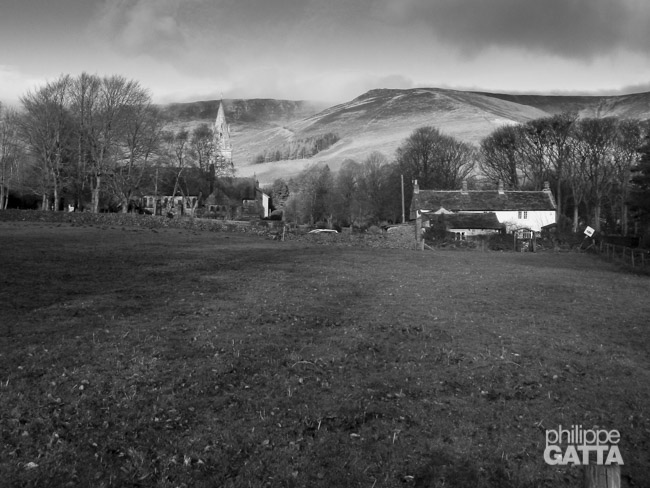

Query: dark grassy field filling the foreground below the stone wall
0 222 650 488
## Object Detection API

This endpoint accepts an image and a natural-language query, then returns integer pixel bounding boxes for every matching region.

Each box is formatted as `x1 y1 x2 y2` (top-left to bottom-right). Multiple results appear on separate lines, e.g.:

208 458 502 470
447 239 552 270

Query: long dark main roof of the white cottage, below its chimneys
414 190 555 212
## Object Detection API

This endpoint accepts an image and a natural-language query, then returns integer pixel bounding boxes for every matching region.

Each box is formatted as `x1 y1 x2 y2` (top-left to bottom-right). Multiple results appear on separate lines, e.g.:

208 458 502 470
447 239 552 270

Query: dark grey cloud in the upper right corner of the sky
401 0 650 59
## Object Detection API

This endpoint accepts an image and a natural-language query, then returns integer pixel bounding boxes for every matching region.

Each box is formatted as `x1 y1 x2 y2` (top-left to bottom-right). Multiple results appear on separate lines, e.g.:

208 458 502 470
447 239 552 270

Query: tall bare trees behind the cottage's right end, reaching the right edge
480 113 647 234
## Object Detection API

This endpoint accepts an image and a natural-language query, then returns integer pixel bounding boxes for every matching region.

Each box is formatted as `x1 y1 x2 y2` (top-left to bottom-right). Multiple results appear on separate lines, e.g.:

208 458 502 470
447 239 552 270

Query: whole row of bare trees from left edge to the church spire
0 73 232 212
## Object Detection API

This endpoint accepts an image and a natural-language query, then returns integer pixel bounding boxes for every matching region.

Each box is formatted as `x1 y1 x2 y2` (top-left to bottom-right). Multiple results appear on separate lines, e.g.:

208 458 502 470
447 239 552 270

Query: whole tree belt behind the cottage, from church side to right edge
267 113 650 234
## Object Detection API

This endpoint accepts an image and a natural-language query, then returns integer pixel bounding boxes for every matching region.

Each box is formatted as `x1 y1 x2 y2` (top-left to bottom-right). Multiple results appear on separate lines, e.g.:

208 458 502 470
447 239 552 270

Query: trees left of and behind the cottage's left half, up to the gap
266 127 477 227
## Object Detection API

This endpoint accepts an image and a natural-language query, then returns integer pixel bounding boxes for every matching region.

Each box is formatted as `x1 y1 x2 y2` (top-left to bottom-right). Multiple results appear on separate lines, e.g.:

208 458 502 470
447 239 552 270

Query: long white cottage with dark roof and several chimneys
411 181 556 234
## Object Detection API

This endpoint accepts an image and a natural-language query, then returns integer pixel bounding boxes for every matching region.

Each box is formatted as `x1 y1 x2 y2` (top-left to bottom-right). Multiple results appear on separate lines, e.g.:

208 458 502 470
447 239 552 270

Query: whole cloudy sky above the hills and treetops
0 0 650 103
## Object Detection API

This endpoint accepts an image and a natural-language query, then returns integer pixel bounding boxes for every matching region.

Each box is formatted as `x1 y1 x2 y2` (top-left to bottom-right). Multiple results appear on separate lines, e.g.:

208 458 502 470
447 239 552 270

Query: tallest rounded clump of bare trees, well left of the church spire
11 73 161 212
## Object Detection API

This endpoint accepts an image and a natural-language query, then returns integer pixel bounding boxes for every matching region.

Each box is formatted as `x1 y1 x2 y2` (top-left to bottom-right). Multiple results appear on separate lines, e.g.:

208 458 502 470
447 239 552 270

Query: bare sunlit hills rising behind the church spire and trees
158 88 650 185
